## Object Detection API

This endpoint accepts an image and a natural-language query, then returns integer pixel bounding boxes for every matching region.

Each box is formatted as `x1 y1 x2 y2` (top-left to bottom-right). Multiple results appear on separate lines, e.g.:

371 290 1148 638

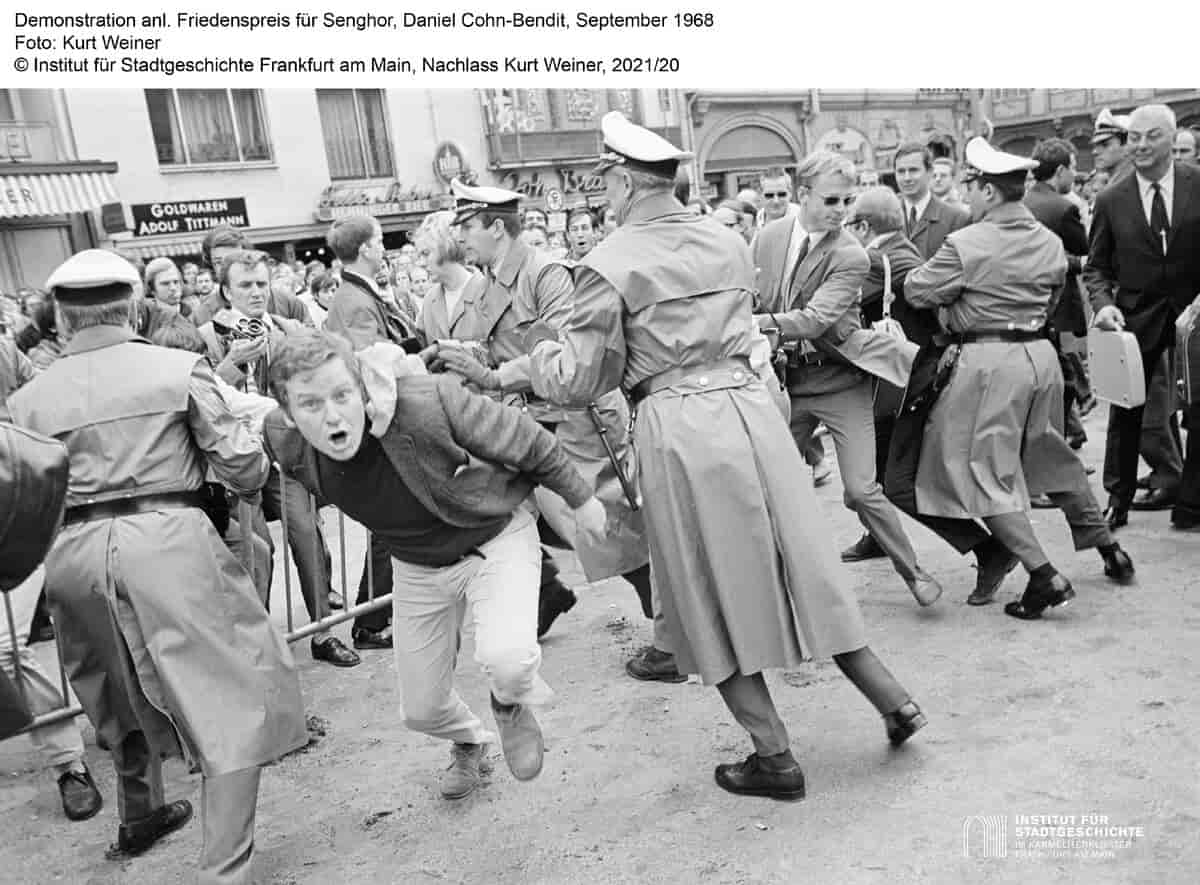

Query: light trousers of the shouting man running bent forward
391 507 553 743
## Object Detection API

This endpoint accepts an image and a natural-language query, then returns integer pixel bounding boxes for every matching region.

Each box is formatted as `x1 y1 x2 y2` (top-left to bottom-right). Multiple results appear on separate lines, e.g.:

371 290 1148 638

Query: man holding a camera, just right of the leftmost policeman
198 249 359 667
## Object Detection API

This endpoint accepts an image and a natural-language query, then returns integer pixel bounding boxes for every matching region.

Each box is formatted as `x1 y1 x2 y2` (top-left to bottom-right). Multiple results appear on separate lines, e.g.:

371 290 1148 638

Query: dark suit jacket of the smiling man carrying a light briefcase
1084 163 1200 348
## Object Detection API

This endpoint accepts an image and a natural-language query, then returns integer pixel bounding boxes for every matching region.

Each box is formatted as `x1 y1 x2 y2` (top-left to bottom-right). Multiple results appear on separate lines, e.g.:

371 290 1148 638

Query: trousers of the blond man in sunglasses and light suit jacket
790 377 917 580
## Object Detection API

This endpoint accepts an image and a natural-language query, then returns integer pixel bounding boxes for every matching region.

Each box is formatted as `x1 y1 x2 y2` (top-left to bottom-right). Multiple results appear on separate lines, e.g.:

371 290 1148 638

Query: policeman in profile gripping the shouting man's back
438 182 685 682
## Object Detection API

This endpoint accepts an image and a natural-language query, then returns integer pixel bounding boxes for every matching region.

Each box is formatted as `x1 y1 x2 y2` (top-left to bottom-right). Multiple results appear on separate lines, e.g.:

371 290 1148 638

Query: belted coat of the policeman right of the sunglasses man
905 203 1079 518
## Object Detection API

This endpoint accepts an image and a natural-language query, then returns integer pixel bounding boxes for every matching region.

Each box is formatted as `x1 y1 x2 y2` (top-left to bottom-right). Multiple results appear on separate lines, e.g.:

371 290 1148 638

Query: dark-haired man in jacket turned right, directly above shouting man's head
325 215 419 650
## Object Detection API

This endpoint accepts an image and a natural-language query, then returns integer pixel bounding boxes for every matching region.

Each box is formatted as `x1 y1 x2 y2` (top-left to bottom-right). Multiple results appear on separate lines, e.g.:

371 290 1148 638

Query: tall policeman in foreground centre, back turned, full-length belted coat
530 112 925 800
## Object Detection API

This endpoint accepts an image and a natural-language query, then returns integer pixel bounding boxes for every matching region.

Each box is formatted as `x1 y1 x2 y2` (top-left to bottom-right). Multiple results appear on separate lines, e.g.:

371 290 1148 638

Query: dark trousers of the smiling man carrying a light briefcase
1104 354 1183 500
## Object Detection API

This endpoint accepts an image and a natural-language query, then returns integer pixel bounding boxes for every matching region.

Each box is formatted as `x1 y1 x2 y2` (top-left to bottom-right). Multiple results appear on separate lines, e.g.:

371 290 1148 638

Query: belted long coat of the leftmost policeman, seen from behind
10 326 307 776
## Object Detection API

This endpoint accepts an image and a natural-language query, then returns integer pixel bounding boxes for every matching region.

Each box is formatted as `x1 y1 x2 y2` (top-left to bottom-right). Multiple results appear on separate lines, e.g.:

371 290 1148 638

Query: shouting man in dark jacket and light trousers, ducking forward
264 331 605 799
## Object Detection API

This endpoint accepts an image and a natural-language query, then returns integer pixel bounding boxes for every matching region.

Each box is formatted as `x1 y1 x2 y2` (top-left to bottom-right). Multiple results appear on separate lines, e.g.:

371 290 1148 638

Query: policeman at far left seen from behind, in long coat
8 249 307 883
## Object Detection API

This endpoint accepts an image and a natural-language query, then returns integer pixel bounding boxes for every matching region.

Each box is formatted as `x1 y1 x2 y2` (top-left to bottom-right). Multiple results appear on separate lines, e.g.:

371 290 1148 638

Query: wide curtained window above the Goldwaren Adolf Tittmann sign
146 89 271 165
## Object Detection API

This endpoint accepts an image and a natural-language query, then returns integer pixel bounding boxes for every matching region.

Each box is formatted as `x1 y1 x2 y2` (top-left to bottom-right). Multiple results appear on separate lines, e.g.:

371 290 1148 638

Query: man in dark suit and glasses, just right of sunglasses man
841 186 938 562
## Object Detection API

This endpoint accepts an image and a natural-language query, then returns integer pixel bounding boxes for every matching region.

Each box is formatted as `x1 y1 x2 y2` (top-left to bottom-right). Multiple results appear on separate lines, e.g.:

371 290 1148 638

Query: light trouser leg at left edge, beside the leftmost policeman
0 566 83 777
